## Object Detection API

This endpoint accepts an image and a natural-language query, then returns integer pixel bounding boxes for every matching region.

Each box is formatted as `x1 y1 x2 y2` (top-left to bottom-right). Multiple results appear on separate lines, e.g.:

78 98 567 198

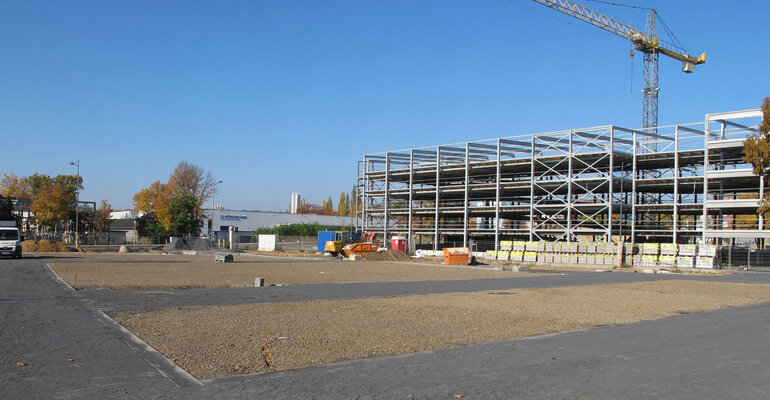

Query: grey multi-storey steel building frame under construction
356 109 770 249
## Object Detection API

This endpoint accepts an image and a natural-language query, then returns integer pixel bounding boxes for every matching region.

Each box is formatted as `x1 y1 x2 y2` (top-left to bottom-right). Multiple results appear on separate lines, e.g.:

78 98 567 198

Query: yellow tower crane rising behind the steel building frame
532 0 706 131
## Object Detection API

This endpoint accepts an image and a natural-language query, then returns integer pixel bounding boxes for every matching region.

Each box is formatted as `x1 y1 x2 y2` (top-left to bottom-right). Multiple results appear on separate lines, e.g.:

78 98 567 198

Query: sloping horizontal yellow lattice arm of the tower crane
532 0 706 67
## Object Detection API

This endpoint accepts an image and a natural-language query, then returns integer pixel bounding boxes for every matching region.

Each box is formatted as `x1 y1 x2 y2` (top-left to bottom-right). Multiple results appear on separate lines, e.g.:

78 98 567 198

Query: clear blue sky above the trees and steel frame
0 0 770 211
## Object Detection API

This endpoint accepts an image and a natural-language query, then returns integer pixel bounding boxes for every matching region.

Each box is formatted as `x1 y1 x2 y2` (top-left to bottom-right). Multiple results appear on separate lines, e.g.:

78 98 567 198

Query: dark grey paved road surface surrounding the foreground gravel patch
0 257 770 399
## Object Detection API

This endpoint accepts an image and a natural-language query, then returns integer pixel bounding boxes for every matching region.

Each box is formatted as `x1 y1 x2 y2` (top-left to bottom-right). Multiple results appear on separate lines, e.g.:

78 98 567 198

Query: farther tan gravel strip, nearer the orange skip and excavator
48 256 522 289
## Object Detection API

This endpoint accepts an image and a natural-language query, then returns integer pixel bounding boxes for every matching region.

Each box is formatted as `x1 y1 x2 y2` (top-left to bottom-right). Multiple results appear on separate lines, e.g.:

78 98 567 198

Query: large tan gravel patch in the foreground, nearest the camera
112 281 770 378
